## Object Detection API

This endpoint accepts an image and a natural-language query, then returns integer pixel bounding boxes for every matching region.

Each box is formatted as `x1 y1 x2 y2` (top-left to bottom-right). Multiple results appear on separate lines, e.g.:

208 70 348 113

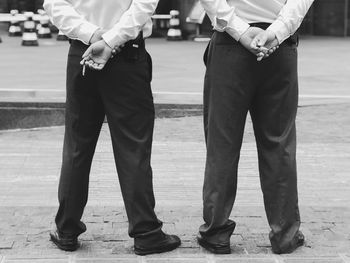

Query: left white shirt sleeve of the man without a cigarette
201 0 249 41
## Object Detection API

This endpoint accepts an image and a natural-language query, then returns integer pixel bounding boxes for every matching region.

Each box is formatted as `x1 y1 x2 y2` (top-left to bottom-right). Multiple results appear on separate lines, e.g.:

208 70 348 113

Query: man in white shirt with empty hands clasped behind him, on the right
198 0 313 254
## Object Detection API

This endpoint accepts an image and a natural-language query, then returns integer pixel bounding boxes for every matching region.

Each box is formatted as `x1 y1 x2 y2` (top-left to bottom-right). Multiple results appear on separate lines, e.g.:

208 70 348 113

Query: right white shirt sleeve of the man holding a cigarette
102 0 159 48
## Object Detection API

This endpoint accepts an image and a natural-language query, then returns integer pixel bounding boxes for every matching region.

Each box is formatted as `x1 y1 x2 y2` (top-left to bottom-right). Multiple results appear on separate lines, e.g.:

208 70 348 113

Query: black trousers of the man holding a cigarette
56 38 162 241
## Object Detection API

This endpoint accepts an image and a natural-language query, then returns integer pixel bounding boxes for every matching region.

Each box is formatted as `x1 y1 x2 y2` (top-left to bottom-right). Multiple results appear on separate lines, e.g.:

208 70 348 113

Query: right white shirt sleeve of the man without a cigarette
268 0 314 43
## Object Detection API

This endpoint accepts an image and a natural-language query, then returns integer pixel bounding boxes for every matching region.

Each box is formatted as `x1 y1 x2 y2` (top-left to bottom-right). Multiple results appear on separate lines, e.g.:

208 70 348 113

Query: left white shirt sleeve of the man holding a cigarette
44 0 98 45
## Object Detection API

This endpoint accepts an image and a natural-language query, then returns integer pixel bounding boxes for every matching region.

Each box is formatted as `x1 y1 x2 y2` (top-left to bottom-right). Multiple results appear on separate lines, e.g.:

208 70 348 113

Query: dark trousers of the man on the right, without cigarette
200 32 300 254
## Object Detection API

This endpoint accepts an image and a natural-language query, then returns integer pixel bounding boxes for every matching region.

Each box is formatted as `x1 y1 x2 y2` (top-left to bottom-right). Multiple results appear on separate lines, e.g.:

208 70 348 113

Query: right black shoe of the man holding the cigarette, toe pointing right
134 233 181 256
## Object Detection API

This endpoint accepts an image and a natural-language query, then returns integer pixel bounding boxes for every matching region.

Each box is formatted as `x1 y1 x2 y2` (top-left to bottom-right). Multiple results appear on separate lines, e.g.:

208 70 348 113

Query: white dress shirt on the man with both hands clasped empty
201 0 314 43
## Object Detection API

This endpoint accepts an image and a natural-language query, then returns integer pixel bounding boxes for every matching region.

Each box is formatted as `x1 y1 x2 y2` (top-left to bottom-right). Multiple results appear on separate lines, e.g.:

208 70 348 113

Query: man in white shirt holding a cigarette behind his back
44 0 180 255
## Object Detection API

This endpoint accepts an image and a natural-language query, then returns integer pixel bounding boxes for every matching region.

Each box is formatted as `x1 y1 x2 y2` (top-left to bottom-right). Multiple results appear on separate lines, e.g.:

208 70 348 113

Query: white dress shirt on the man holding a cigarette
44 0 159 48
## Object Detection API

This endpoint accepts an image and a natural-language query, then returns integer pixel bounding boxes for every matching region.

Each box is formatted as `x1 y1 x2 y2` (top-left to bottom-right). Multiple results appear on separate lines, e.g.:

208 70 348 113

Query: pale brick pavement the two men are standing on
0 104 350 263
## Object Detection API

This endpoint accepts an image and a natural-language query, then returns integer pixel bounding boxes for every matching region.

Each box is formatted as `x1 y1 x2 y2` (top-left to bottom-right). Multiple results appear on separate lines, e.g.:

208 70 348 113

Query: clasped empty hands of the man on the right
239 27 279 61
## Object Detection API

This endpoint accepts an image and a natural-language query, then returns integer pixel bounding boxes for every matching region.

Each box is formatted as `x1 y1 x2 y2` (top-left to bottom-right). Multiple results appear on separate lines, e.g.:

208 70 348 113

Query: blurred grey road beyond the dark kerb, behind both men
0 35 350 104
